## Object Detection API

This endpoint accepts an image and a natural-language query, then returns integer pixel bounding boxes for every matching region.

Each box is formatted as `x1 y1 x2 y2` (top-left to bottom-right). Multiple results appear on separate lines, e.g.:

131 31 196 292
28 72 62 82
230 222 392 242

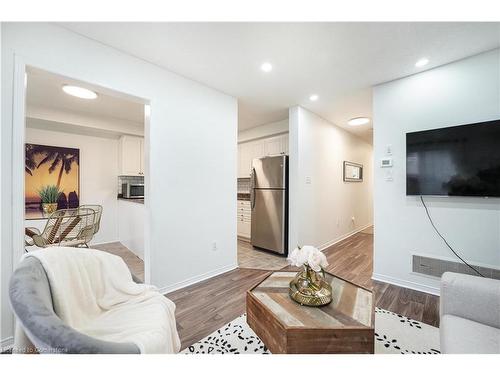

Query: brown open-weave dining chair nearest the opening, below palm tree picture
25 207 96 247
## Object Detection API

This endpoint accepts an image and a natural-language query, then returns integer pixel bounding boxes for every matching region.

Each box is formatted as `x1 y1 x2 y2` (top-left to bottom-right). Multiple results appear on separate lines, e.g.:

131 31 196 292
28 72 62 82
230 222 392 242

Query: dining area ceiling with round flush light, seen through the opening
26 67 144 127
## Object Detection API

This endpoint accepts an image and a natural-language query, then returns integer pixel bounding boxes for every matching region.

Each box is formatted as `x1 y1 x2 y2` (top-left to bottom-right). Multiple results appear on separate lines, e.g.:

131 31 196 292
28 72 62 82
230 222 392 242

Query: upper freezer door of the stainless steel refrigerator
251 155 287 189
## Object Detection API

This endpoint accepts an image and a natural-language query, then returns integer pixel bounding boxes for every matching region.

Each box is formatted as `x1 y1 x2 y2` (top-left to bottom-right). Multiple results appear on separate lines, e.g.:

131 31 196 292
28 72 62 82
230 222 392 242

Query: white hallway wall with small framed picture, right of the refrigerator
290 107 373 253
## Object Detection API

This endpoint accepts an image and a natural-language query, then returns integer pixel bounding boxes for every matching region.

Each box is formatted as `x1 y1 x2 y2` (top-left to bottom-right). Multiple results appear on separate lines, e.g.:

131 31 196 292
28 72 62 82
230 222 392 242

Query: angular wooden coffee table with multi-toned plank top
247 271 375 354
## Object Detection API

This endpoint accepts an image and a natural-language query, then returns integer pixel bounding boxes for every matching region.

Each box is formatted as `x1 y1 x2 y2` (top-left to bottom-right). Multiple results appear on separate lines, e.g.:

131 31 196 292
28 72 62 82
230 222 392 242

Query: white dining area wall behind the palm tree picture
26 125 118 244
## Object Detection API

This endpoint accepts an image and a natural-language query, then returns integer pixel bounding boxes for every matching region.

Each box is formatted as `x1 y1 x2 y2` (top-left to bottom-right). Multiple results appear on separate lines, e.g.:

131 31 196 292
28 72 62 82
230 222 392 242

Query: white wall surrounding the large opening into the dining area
0 23 237 346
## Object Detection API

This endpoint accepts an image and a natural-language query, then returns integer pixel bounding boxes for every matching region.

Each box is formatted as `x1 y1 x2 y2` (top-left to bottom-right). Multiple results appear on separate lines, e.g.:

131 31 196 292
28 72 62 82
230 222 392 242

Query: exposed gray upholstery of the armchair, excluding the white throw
9 257 140 354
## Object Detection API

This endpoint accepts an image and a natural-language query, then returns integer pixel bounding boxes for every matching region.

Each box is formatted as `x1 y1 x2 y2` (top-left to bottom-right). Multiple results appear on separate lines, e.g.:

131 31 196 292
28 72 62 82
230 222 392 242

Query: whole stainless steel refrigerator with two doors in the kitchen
250 155 288 255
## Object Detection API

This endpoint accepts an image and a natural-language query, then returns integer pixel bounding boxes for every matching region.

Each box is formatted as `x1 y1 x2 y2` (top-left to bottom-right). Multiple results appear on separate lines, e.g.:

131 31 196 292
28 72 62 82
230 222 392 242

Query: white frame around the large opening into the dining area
12 54 152 284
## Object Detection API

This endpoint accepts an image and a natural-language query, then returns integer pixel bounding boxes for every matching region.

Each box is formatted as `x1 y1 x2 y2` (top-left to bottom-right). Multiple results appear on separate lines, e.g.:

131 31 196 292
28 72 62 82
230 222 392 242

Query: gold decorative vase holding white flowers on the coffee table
289 265 332 306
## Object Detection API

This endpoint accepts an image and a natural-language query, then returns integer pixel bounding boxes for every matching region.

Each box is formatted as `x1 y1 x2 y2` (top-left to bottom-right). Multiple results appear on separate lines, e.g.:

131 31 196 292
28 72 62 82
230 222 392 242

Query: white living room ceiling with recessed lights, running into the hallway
56 23 500 140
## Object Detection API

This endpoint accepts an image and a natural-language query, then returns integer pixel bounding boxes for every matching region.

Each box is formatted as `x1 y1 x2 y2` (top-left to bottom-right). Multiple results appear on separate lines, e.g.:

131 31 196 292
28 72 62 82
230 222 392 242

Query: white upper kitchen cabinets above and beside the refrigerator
238 133 288 178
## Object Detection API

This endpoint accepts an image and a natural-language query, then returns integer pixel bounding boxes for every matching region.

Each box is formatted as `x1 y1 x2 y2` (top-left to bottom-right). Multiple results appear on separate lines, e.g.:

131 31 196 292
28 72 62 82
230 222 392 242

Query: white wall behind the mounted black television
373 50 500 293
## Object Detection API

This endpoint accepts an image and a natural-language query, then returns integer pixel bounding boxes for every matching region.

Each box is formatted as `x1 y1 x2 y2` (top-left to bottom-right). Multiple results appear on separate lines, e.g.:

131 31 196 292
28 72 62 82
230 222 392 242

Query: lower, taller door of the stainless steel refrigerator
250 189 286 254
